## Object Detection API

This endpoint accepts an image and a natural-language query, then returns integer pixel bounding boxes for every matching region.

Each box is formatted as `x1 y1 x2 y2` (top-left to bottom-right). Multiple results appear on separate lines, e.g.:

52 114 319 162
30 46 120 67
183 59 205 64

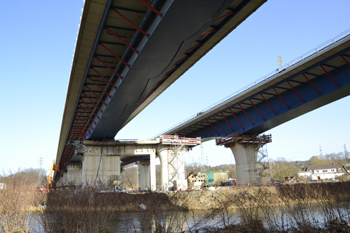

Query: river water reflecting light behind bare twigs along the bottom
30 202 350 233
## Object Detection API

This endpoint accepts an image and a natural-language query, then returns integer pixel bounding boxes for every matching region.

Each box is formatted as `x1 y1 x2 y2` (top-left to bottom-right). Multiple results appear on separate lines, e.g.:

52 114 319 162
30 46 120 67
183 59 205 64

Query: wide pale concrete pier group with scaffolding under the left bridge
57 135 201 191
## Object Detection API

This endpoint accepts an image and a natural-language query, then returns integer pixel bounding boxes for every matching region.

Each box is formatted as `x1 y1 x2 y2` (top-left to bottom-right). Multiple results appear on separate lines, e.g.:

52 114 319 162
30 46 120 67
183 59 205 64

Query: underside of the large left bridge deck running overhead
56 0 266 180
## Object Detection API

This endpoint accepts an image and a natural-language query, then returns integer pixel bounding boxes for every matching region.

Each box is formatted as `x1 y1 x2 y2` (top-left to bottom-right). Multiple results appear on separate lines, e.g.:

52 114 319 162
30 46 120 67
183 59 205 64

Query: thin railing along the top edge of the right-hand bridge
154 28 350 137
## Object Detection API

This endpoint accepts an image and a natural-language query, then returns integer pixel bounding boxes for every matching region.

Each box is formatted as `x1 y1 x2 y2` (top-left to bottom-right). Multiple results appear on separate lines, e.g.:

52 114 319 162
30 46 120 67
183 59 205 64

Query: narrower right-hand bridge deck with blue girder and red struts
164 40 350 141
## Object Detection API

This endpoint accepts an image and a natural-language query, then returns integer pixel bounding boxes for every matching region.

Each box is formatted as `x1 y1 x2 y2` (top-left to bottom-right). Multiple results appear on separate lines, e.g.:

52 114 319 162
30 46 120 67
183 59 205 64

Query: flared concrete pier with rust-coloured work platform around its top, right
216 134 272 185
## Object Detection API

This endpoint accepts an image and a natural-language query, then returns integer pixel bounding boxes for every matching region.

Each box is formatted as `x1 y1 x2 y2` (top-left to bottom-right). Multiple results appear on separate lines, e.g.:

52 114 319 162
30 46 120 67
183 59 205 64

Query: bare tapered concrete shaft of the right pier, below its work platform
230 143 258 185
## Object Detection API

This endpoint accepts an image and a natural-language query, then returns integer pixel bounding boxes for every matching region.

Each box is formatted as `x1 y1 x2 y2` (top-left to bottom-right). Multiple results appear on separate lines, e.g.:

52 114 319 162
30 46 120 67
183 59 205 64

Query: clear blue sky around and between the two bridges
0 0 350 171
